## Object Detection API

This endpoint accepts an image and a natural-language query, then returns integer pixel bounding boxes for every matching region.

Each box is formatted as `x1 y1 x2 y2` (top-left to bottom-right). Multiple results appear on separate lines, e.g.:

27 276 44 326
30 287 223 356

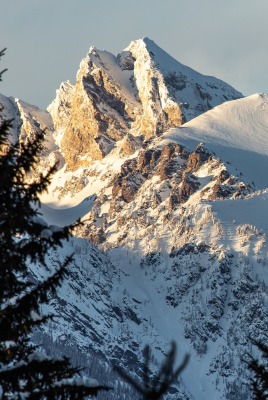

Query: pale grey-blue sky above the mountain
0 0 268 109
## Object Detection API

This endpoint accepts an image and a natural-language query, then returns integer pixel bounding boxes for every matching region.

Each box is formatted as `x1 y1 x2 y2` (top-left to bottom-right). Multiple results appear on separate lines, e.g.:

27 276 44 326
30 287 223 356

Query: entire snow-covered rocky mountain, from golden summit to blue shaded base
0 39 268 400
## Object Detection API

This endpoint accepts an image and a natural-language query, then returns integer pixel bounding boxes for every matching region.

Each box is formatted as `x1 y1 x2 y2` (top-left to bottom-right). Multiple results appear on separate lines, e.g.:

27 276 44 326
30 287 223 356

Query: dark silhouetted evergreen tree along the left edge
0 51 108 400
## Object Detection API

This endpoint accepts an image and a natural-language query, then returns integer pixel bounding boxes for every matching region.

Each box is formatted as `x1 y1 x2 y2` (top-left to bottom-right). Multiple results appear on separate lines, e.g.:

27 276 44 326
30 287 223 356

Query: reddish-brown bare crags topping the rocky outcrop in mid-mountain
110 143 207 215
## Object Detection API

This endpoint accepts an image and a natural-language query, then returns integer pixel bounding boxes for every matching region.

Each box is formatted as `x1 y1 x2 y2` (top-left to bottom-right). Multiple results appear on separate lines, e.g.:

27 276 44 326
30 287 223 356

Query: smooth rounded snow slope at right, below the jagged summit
165 94 268 188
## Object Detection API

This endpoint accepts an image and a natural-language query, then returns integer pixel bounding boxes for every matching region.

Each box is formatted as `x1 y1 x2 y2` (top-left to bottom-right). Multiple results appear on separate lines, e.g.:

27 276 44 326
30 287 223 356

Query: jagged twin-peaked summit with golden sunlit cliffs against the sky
48 38 242 171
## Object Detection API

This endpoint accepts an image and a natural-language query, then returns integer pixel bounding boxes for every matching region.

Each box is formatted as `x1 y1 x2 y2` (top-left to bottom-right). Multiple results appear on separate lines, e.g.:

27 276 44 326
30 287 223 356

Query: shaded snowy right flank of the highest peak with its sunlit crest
126 38 242 121
